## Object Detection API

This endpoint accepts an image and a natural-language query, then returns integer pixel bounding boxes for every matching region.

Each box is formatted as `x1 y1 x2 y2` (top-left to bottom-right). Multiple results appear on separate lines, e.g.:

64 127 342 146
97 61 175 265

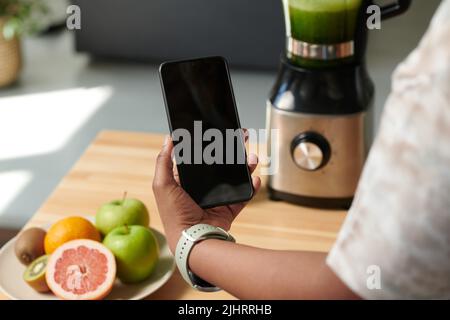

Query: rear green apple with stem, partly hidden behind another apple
95 199 150 236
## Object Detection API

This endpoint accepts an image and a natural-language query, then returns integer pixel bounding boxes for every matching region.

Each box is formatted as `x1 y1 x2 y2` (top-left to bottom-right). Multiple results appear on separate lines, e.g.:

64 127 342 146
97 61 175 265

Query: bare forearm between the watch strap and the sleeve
189 240 358 299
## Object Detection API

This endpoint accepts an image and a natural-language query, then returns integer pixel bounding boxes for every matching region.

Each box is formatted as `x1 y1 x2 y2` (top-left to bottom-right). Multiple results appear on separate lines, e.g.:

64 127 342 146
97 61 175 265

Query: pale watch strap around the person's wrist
175 224 236 292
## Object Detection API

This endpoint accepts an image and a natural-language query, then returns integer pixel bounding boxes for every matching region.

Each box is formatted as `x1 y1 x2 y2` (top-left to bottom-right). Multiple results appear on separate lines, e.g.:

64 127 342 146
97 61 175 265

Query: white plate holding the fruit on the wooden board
0 229 175 300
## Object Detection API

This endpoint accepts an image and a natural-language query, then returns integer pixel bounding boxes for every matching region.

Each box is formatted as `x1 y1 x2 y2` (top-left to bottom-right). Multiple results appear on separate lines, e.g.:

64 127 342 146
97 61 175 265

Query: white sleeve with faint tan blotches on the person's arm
327 0 450 299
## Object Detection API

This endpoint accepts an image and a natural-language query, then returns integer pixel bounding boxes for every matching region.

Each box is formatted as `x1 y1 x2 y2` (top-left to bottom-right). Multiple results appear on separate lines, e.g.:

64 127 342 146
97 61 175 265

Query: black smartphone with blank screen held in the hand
159 57 253 208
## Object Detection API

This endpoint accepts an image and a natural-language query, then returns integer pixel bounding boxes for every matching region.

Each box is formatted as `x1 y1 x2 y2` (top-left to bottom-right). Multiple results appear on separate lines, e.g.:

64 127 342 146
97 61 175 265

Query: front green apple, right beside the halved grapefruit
103 226 159 283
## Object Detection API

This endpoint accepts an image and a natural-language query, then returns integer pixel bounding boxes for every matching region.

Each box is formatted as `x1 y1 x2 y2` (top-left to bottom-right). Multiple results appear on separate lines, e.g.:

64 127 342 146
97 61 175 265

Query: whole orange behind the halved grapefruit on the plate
44 217 101 254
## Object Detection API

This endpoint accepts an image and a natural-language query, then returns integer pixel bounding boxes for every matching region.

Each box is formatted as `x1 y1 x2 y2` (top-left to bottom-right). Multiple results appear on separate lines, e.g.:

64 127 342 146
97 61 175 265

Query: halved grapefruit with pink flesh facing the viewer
46 239 116 300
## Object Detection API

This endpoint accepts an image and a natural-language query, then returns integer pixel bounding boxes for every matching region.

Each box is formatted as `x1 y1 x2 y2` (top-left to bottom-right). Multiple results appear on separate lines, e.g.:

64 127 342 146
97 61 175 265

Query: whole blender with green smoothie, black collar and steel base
267 0 411 208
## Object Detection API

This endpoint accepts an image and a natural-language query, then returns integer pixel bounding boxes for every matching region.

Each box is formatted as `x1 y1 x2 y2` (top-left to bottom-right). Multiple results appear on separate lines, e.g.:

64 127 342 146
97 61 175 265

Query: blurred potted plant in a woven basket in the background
0 0 46 87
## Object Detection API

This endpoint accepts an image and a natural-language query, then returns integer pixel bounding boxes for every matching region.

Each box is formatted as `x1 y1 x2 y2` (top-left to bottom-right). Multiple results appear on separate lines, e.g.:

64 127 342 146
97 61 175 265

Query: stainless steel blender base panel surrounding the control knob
268 106 371 208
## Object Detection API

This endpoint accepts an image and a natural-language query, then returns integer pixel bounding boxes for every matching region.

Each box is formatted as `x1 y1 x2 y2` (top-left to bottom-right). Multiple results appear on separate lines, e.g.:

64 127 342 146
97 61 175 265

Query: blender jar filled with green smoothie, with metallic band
283 0 364 67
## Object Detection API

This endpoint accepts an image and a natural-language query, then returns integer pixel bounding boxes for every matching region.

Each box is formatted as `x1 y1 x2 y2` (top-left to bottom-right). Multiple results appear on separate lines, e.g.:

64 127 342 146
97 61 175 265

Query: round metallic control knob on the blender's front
291 132 331 171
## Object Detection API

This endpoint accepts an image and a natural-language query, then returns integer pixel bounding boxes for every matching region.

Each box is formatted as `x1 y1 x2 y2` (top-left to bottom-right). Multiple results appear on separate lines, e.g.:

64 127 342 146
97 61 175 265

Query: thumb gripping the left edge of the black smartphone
153 136 177 191
